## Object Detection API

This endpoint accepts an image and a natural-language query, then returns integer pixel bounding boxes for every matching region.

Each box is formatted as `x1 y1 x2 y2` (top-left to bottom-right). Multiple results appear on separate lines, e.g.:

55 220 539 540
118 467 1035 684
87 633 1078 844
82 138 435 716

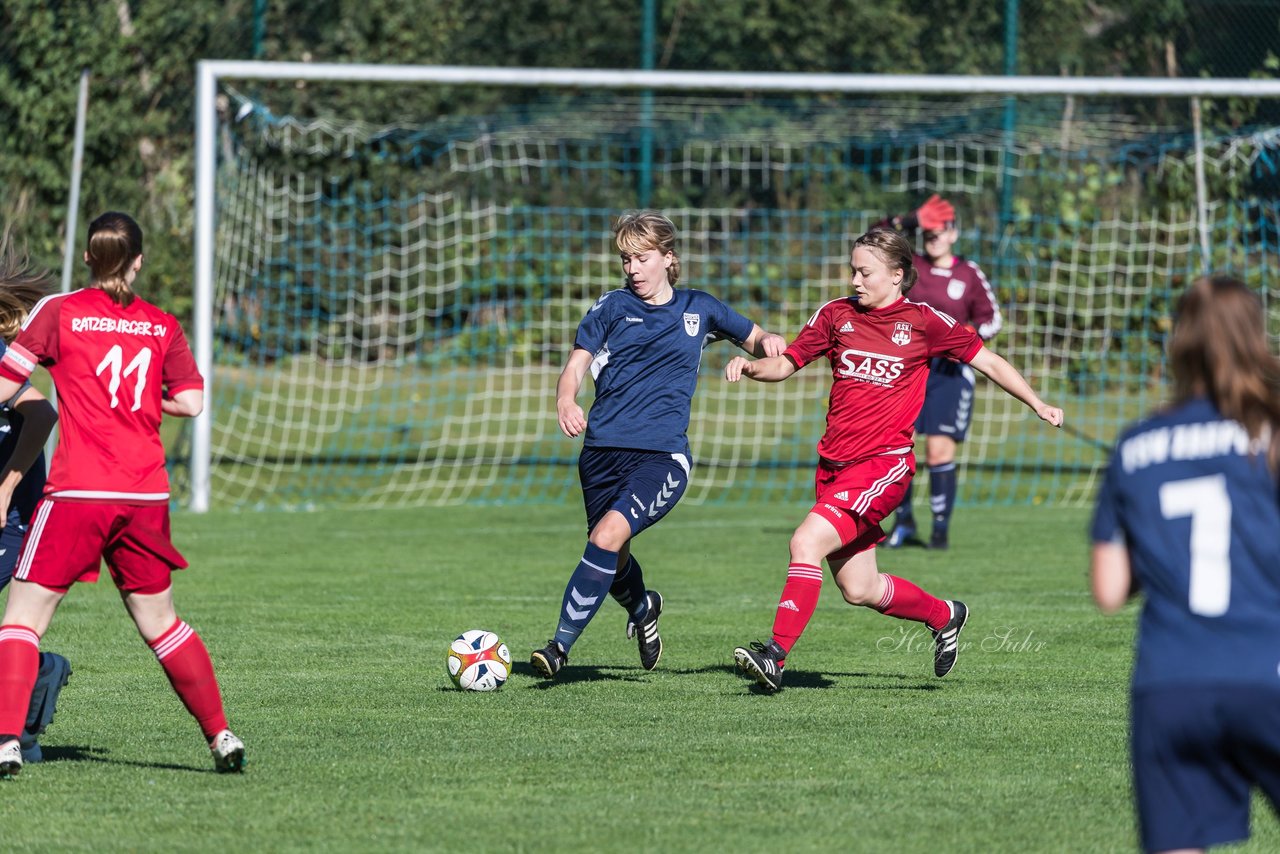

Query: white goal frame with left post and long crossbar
189 60 1280 512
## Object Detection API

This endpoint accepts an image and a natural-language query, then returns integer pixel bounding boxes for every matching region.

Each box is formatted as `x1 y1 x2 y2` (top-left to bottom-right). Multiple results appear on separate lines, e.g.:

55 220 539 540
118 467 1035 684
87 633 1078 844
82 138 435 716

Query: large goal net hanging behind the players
193 65 1280 507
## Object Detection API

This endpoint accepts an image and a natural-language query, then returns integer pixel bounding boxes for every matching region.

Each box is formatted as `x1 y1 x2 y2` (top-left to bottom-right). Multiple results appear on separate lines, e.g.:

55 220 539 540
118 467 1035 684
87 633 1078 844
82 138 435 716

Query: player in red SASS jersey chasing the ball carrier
724 229 1062 691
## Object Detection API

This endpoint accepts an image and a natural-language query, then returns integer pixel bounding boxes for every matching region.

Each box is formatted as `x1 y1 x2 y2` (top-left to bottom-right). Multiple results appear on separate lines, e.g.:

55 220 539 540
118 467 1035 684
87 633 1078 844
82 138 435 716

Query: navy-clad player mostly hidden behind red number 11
0 239 72 763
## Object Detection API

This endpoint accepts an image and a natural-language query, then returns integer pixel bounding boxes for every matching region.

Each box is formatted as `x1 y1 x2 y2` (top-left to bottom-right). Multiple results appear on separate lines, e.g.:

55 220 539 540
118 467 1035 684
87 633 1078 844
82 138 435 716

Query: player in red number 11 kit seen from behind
0 213 244 776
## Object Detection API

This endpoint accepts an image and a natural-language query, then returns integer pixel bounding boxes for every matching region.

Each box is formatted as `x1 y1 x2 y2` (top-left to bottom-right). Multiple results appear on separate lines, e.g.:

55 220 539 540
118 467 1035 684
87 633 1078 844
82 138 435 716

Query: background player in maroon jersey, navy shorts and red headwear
879 195 1004 549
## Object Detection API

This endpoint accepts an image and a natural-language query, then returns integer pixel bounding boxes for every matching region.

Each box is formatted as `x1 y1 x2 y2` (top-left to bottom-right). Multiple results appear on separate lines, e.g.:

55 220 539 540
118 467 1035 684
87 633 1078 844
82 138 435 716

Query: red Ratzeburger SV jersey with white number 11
0 277 204 504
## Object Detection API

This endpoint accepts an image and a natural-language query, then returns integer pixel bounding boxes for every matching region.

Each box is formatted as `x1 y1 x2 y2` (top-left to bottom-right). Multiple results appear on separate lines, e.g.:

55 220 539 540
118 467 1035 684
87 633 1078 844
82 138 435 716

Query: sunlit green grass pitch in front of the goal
0 506 1280 851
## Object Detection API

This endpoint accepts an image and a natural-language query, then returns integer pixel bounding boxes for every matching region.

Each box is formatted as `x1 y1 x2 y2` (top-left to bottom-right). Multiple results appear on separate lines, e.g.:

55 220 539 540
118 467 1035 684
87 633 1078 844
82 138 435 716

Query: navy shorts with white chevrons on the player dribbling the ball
577 448 689 536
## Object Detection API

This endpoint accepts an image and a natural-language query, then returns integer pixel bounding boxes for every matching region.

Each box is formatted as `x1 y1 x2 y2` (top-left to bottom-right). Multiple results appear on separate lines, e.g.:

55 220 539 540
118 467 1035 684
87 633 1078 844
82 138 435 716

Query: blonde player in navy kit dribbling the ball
530 210 787 679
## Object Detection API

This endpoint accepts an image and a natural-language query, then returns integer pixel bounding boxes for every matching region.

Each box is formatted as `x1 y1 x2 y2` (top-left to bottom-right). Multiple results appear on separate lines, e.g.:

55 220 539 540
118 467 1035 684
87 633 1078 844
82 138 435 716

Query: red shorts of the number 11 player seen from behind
13 498 187 594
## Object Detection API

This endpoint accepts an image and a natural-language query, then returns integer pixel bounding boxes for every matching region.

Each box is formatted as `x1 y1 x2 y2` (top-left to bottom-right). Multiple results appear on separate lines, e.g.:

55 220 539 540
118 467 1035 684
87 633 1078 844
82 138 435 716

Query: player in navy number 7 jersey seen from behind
1091 277 1280 851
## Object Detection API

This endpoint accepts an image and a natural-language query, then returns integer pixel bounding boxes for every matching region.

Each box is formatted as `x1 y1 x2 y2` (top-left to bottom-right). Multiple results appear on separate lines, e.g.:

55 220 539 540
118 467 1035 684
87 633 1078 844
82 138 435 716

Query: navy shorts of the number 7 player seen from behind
1129 685 1280 851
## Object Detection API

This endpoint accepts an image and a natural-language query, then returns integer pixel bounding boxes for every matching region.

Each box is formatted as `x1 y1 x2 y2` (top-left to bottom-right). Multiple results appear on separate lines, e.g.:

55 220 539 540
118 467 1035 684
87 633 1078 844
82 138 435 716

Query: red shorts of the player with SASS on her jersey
810 453 915 560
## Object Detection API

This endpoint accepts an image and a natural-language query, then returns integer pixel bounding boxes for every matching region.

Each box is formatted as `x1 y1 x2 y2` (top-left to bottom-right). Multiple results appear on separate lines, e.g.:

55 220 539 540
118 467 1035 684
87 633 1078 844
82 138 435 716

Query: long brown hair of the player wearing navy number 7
1169 275 1280 471
